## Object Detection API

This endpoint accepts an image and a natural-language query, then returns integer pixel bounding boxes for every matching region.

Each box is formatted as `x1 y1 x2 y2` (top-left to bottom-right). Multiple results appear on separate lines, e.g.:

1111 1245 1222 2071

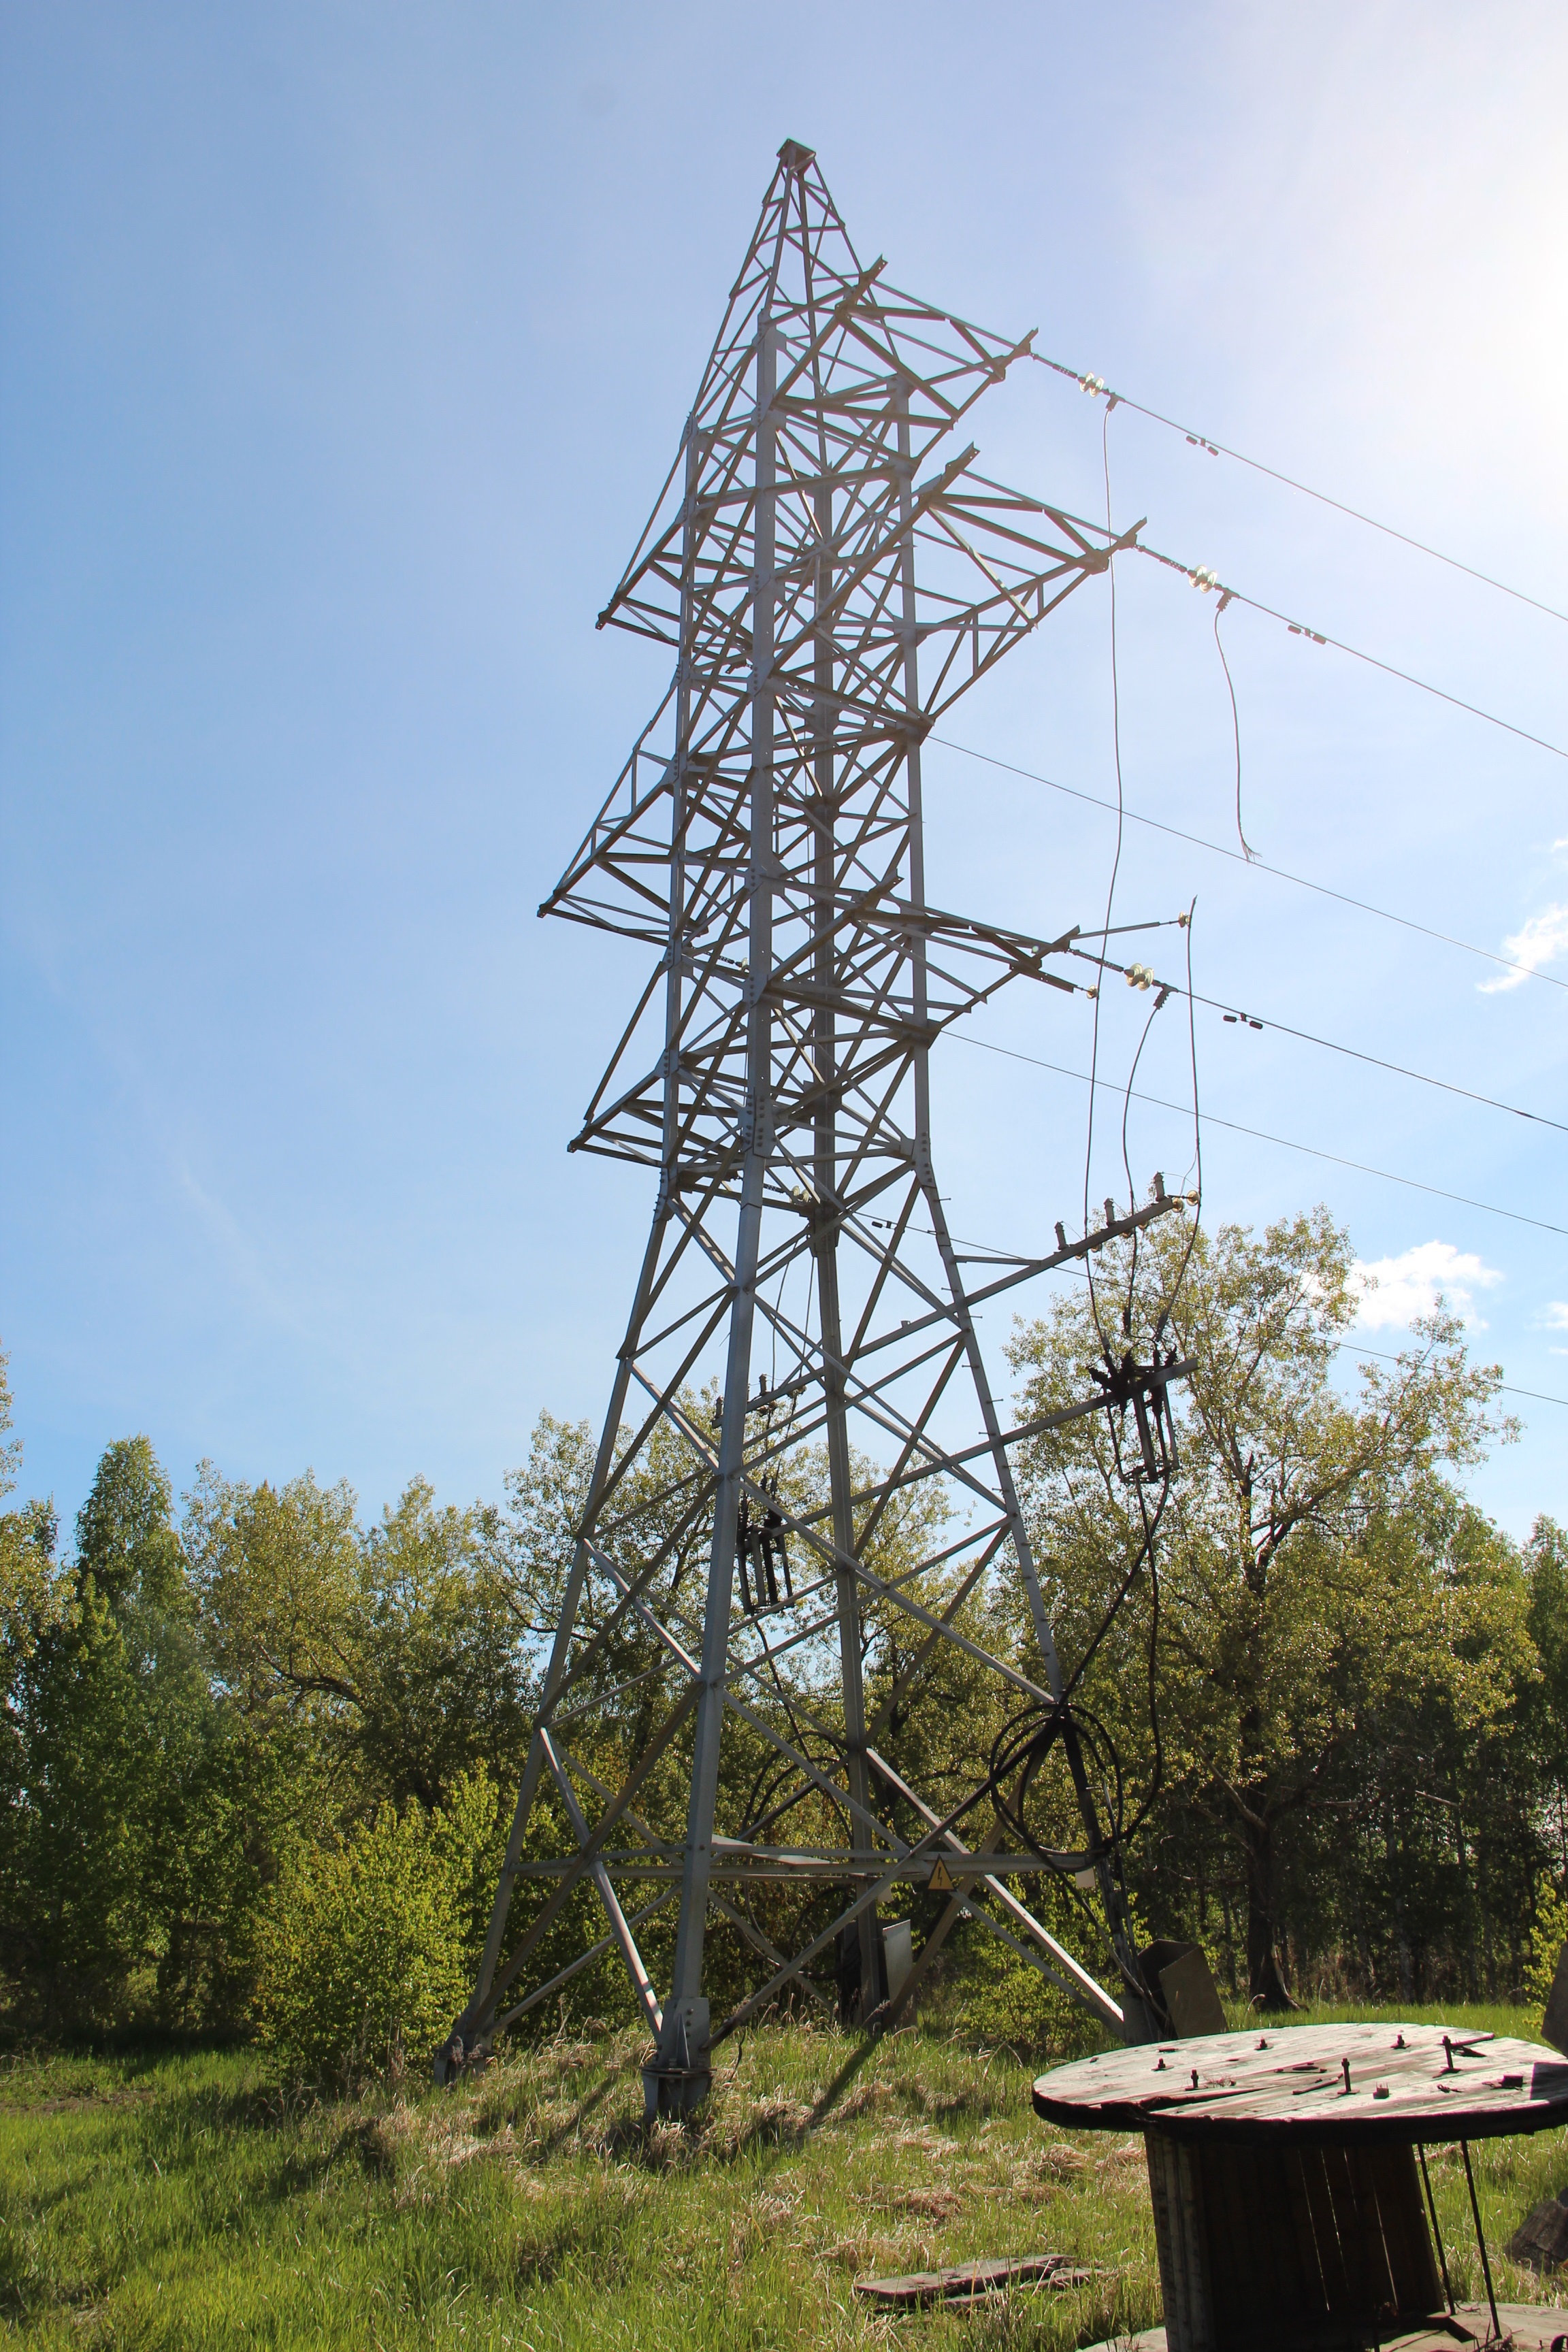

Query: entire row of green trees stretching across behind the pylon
0 1209 1568 2065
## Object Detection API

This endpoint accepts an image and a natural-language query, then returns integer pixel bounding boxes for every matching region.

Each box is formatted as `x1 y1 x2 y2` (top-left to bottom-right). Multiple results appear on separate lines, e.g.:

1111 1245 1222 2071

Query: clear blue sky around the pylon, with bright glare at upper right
0 0 1568 1533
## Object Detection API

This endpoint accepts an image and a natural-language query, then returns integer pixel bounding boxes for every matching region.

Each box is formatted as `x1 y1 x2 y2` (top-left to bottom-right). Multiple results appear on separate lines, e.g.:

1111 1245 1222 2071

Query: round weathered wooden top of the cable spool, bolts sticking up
1034 2025 1568 2145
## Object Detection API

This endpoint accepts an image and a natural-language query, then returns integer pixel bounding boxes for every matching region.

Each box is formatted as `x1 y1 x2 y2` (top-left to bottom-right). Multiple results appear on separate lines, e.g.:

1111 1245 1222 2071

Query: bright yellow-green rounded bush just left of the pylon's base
254 1774 496 2084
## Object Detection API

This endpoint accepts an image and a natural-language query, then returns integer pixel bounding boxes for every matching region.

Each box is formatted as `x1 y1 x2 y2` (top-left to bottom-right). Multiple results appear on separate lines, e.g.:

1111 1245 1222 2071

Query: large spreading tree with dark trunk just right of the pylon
1013 1209 1528 2006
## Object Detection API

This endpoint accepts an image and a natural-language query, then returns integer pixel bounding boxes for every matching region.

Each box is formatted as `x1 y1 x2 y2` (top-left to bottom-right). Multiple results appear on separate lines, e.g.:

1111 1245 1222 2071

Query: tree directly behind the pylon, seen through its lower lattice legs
506 1390 968 2011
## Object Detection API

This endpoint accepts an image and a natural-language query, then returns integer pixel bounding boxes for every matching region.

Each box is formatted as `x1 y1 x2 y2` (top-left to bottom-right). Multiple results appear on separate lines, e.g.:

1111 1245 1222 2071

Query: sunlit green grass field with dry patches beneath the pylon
0 2008 1568 2352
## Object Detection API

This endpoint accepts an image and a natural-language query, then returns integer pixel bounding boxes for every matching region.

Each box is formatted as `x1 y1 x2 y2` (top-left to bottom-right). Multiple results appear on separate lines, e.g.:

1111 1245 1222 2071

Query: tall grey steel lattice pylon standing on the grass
446 141 1184 2112
